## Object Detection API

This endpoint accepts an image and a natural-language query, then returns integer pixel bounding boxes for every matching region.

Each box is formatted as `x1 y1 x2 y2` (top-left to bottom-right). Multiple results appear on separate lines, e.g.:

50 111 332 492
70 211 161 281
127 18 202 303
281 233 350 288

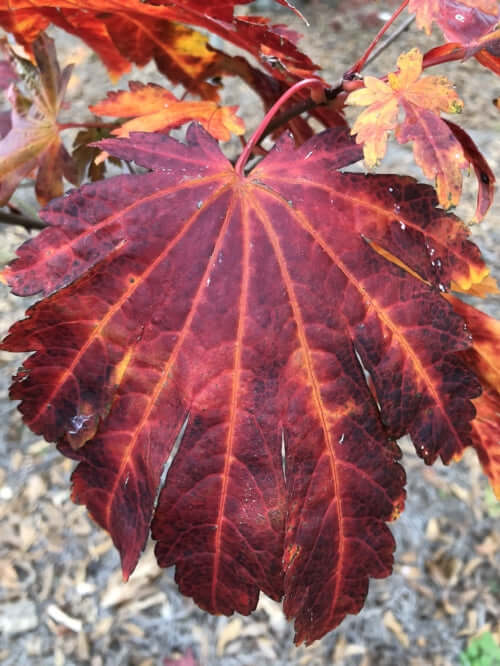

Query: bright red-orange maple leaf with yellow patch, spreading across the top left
0 0 332 143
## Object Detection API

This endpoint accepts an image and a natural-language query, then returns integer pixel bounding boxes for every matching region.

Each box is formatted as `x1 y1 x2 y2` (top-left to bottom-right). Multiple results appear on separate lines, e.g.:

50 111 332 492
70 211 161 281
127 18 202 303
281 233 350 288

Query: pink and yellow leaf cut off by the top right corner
408 0 499 45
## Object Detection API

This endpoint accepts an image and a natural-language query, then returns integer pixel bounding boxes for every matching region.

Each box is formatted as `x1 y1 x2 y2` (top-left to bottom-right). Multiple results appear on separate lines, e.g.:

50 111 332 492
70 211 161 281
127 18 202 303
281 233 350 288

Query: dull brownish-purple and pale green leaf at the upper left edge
0 35 77 204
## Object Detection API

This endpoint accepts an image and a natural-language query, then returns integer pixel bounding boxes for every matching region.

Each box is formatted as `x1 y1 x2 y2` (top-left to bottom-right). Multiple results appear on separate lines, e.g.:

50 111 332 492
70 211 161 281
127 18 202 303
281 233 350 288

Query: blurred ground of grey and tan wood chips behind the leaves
0 0 500 666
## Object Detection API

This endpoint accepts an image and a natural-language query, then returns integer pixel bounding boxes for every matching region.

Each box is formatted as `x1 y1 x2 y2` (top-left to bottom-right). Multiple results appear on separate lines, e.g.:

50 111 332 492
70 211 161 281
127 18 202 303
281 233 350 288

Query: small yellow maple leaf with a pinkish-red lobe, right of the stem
346 49 474 208
